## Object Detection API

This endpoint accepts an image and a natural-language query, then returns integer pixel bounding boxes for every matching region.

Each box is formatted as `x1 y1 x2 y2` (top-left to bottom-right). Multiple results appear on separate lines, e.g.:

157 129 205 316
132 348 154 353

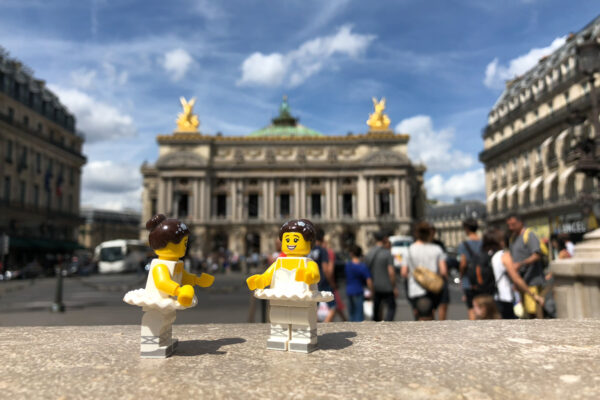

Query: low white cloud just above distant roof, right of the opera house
425 168 485 201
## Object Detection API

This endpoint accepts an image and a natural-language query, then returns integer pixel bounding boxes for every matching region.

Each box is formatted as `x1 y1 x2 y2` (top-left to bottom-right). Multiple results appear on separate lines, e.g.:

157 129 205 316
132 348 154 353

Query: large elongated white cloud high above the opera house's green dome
237 25 375 86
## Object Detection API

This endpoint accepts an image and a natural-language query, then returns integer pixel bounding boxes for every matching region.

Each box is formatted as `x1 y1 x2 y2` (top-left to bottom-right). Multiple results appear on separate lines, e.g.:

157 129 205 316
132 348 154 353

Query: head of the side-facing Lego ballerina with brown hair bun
146 214 190 260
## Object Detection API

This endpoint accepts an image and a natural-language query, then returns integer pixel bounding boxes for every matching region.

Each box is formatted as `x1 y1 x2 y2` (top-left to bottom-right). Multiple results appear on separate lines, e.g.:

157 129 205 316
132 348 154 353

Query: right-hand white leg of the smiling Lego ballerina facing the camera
289 304 318 353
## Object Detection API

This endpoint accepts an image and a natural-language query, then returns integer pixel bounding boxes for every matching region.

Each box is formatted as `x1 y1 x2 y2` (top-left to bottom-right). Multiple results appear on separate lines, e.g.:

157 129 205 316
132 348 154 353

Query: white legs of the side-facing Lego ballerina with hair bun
140 307 177 358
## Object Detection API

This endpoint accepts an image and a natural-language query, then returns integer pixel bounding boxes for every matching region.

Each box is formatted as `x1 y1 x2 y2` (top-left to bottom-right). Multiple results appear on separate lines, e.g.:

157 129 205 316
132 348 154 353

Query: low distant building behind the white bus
79 207 141 250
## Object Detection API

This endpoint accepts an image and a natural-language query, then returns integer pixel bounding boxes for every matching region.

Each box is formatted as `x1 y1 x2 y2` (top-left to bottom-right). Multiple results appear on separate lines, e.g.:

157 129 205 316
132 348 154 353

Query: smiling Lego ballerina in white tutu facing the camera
246 219 333 353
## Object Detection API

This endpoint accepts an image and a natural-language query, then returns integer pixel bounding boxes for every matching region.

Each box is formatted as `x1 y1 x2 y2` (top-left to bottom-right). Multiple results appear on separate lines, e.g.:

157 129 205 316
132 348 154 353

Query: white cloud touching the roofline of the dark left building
49 85 137 143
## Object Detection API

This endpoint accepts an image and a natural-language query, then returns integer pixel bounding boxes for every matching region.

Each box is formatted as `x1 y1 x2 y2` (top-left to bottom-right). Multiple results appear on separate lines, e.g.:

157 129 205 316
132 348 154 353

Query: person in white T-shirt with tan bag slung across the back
402 222 448 320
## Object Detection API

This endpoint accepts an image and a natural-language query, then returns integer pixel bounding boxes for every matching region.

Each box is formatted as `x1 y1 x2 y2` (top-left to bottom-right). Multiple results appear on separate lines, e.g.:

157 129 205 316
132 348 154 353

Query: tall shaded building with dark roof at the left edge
0 49 86 268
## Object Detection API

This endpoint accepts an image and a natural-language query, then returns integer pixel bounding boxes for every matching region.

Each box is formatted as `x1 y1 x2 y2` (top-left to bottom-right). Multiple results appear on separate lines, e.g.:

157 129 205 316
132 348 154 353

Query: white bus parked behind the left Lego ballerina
94 239 149 274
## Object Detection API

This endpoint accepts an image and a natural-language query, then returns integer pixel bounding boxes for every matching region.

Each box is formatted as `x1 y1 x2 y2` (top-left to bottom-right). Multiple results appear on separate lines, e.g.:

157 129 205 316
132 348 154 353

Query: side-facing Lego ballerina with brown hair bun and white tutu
123 214 215 358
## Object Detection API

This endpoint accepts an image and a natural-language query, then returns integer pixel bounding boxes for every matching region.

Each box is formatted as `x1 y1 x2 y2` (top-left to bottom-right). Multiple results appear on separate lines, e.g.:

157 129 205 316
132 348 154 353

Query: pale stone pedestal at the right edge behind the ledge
550 229 600 319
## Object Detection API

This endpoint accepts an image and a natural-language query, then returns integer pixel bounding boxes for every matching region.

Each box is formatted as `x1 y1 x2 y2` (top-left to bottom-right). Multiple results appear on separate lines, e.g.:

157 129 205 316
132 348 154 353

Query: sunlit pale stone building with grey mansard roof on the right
479 17 600 238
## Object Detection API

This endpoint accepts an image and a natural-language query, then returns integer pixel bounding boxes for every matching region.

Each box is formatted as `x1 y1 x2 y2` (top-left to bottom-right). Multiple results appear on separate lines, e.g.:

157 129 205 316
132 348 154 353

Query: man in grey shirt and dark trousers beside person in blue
365 232 398 321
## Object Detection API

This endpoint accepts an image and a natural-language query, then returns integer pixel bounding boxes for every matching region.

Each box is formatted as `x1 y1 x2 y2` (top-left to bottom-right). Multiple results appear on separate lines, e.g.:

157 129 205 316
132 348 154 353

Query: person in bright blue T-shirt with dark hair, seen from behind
346 245 373 322
